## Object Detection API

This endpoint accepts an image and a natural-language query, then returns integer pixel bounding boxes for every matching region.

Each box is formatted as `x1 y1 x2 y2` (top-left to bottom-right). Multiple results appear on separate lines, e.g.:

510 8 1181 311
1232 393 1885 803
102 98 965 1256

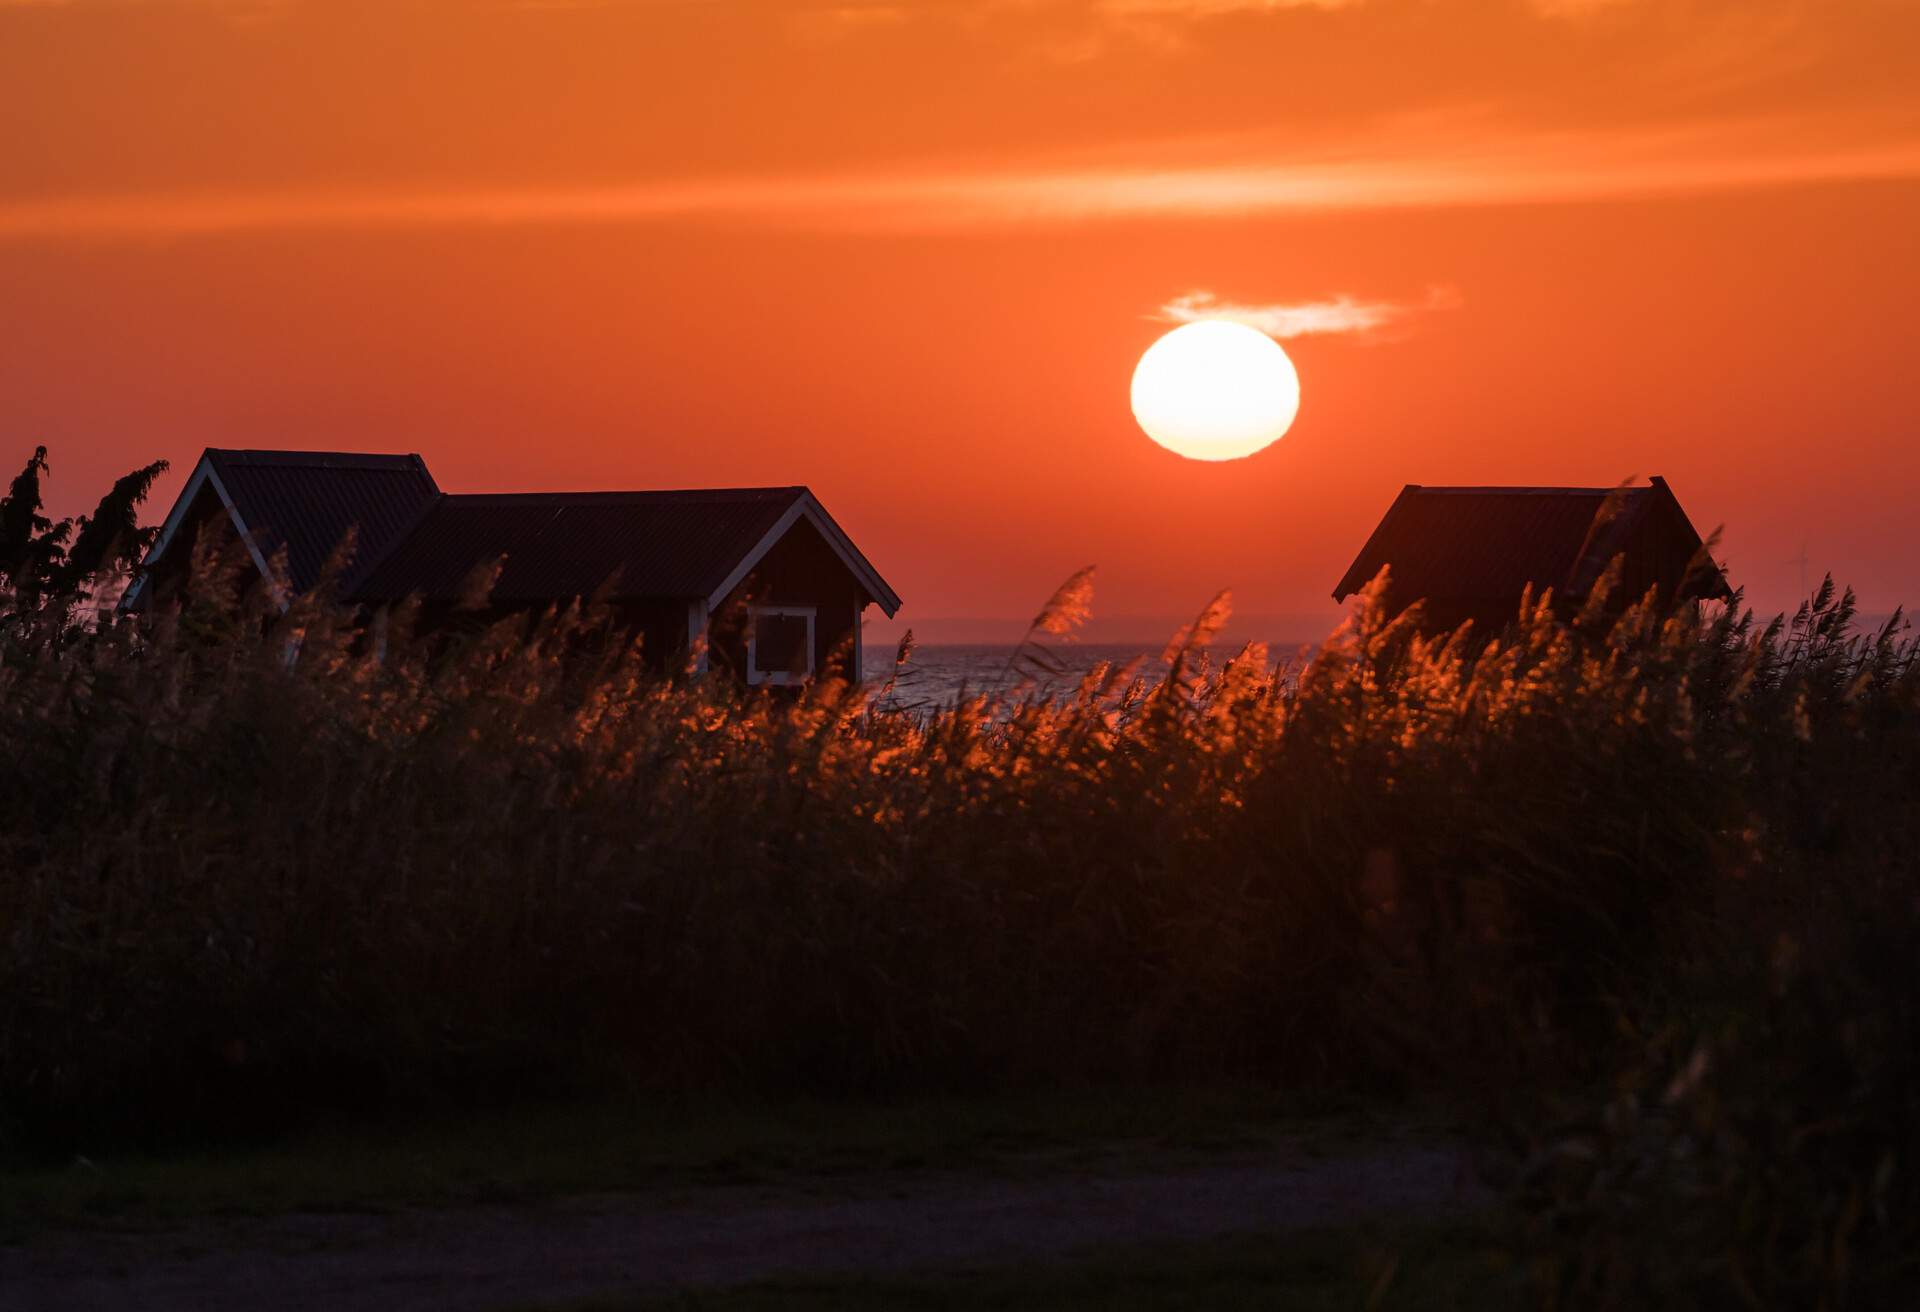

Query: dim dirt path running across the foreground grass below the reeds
0 1147 1473 1312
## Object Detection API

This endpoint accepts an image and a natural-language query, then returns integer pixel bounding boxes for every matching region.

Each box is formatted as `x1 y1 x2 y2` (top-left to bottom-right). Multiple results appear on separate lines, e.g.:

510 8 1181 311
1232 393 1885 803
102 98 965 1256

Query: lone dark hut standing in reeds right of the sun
1332 478 1732 634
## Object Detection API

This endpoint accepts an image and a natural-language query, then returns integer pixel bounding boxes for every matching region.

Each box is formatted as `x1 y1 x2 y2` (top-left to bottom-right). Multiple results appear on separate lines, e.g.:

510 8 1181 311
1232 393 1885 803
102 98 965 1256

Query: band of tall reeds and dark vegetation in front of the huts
0 457 1920 1308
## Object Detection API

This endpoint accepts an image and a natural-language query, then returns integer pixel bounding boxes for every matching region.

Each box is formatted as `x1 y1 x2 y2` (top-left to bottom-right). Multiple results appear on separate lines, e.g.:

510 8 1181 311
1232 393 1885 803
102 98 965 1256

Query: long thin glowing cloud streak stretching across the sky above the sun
0 121 1920 242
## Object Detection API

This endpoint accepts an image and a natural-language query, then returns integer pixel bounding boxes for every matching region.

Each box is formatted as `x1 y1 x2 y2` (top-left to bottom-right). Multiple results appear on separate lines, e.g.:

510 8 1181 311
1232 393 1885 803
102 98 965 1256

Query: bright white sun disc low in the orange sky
1133 319 1300 461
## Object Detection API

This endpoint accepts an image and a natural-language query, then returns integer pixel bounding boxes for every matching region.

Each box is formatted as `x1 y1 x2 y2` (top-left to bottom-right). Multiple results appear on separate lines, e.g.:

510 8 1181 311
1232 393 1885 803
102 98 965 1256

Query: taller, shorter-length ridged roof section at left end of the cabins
205 448 440 592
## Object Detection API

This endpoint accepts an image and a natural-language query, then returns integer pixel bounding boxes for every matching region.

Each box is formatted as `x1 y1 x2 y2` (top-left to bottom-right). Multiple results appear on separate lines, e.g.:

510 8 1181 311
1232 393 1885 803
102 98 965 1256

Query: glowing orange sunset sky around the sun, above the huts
0 0 1920 640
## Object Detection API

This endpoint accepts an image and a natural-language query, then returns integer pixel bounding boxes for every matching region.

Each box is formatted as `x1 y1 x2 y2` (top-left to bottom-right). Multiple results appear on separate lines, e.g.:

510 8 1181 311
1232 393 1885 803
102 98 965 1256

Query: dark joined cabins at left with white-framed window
125 448 900 684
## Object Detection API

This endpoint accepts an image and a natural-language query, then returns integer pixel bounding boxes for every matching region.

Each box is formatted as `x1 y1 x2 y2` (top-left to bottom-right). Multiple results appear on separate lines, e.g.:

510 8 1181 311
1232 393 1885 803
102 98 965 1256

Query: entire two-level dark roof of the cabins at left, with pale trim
129 448 900 615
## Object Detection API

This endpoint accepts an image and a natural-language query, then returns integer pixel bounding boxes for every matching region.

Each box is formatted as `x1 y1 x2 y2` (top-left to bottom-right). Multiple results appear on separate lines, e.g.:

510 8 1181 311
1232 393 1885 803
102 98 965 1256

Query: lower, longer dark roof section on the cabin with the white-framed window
353 488 806 605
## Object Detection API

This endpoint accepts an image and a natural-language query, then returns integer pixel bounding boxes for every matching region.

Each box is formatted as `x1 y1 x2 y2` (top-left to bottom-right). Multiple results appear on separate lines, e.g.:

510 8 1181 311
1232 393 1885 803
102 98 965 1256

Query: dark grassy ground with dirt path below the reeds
0 1095 1503 1310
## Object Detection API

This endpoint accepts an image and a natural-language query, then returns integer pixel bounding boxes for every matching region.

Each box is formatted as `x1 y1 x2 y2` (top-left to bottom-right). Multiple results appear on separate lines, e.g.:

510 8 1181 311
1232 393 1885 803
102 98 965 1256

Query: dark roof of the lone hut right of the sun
1332 476 1730 603
